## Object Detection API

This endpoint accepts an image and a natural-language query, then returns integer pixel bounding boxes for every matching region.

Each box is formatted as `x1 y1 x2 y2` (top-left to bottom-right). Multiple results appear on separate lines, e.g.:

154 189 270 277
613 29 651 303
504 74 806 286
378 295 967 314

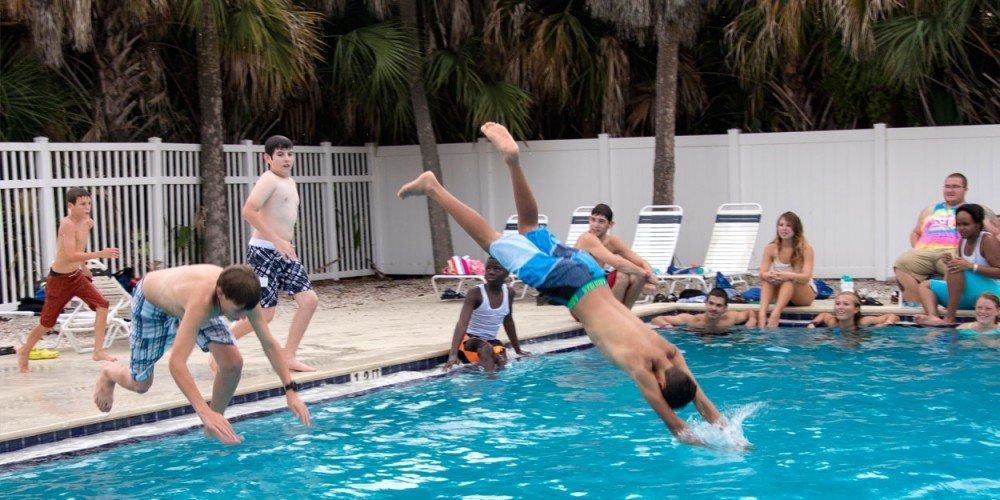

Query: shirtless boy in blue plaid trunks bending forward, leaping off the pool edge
94 264 309 444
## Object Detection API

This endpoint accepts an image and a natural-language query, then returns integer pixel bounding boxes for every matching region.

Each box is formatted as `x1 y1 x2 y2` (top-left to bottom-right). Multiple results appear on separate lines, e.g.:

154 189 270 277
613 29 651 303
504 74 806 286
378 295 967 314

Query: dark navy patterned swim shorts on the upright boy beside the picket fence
247 238 312 307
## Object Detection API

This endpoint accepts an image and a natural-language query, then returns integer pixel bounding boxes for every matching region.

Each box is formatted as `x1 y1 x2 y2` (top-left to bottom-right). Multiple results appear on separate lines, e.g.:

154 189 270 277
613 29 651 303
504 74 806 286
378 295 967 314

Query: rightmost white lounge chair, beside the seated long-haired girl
670 203 763 291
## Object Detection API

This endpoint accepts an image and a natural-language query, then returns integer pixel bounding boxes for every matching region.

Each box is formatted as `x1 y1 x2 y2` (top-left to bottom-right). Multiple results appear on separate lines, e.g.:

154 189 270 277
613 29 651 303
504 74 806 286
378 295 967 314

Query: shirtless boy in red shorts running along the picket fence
17 188 120 373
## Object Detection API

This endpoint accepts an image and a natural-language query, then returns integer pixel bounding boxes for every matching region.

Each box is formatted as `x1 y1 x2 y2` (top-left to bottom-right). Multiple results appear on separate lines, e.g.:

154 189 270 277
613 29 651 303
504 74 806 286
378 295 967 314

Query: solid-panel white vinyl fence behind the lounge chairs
374 125 1000 279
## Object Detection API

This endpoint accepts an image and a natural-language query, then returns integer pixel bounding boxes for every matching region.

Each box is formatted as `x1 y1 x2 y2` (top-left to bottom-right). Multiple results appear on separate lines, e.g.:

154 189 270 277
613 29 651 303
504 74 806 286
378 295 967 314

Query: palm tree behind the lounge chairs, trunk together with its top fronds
587 0 715 204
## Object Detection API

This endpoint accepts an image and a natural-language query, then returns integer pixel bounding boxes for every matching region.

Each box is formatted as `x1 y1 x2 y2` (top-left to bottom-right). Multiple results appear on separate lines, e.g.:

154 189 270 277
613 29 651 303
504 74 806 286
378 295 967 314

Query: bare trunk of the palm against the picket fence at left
196 6 232 266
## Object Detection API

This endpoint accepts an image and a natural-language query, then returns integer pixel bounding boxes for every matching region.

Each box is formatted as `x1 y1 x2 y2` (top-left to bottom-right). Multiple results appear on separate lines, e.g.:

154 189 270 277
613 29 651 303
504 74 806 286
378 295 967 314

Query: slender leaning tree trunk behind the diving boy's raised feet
399 0 454 271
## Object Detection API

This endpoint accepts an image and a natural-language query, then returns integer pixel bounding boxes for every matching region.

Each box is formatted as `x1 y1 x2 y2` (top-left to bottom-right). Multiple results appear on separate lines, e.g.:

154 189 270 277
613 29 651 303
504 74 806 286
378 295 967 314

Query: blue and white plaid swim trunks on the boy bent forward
129 281 236 382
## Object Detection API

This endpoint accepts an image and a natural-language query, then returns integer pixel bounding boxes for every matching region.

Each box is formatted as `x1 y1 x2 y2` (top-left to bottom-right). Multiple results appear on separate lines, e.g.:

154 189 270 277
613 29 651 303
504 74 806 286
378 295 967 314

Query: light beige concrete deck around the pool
0 295 952 449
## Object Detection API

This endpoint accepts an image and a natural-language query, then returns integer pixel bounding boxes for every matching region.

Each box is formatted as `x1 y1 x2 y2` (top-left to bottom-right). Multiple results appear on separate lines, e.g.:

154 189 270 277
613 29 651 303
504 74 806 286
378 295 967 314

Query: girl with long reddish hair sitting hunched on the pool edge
757 212 816 327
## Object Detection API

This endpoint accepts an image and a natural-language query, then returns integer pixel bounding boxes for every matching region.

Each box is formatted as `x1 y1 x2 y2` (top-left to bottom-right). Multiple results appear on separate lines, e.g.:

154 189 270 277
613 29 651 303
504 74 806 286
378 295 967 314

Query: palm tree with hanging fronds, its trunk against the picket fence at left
180 0 320 265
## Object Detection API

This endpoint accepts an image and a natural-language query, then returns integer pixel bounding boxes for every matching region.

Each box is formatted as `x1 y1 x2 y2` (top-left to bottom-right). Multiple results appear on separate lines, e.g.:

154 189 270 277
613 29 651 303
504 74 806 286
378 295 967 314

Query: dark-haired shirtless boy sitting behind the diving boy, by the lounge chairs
576 203 656 309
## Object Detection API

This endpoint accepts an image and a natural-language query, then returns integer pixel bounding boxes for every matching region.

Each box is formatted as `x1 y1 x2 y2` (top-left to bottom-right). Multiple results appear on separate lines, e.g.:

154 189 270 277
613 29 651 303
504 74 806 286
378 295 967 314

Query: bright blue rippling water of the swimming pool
0 328 1000 498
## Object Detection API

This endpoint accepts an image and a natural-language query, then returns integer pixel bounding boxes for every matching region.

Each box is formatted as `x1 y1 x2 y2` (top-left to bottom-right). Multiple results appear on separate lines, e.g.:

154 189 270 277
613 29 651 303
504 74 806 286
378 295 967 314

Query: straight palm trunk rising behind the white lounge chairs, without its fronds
653 14 680 205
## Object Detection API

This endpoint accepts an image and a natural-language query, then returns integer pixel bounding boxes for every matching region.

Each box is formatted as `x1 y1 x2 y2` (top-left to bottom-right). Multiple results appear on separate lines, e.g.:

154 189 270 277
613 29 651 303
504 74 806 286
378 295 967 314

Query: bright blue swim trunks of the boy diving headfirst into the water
490 227 607 309
